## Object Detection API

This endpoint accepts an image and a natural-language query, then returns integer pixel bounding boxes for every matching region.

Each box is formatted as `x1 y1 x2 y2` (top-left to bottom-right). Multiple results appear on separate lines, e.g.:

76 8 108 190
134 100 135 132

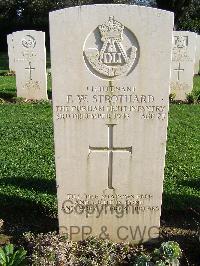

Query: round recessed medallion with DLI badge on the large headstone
84 17 139 79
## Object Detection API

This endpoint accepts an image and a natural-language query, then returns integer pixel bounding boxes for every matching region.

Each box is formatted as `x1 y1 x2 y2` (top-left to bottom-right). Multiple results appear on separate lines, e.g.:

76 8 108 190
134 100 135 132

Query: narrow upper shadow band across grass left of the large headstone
0 176 56 195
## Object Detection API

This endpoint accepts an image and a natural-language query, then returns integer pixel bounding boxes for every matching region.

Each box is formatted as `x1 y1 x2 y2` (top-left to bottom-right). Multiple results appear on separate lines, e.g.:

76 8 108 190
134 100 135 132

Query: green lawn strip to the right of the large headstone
164 104 200 210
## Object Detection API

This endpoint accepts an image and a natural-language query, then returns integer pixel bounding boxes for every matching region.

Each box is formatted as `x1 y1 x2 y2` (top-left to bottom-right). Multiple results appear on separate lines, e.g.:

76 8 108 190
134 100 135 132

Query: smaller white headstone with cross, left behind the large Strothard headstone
13 30 47 100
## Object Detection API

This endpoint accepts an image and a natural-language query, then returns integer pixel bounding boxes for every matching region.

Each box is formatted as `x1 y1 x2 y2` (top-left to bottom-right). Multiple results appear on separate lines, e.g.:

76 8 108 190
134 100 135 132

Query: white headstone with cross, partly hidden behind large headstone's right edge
171 31 197 101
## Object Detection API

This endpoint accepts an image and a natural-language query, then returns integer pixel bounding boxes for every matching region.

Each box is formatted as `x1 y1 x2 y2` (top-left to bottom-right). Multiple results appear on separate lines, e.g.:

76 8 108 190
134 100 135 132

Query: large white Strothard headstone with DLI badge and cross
50 5 173 242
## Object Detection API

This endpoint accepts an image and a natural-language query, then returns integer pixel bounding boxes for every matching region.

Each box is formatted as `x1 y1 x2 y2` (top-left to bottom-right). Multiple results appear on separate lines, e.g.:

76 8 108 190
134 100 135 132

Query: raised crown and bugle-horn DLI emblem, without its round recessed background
84 16 138 78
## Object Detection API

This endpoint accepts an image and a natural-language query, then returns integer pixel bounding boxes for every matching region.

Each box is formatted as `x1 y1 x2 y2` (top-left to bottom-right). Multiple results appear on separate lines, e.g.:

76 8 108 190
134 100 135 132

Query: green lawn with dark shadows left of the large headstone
0 103 56 232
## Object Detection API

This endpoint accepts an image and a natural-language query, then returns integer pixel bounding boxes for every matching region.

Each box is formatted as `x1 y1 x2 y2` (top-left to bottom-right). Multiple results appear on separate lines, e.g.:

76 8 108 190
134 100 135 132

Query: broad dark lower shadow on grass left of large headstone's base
0 191 58 236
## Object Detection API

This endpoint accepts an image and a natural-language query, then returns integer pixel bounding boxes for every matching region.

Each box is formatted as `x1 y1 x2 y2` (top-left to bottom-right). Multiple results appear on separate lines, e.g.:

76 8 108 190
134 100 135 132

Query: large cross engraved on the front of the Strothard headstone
89 124 132 189
